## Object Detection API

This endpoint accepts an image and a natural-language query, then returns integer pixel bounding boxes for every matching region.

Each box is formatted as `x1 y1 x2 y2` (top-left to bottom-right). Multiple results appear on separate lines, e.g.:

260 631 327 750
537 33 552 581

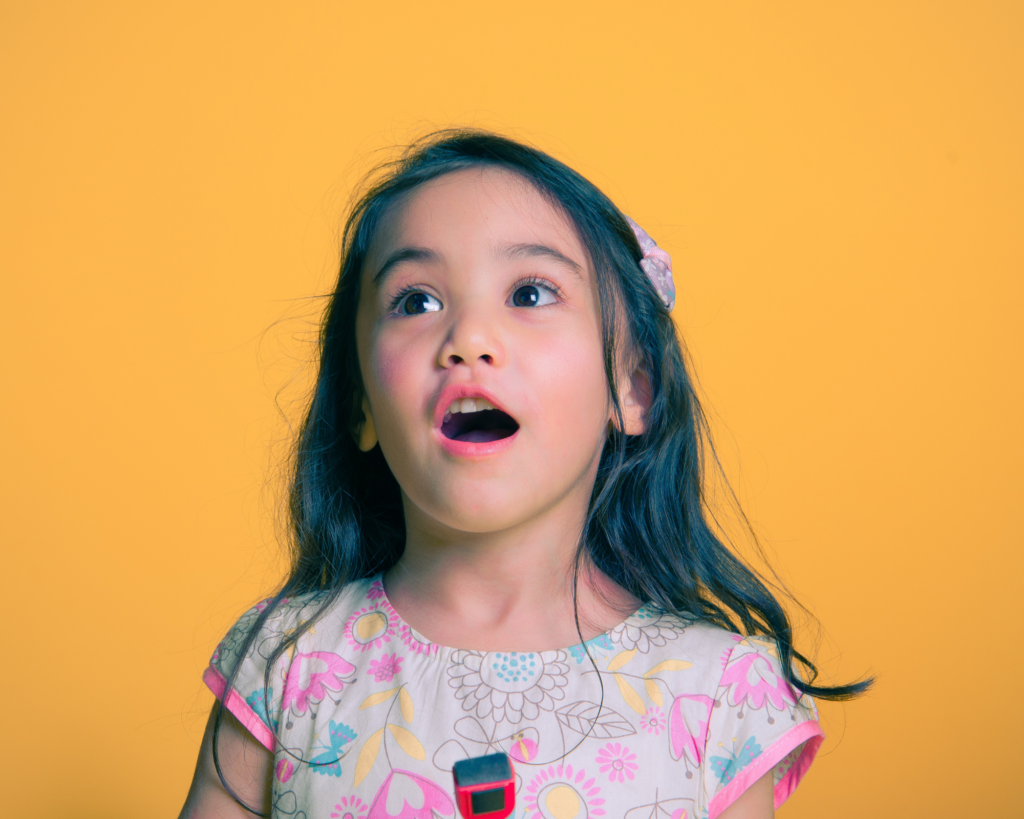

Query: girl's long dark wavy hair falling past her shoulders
213 130 872 810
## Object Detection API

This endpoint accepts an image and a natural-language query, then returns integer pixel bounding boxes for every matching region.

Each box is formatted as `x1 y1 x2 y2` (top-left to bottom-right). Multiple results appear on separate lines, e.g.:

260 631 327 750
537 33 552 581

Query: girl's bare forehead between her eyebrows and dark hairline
366 167 589 270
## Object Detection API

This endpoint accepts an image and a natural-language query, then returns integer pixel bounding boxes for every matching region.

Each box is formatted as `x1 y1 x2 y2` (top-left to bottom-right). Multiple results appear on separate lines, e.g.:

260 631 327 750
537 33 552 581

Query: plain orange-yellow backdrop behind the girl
0 0 1024 819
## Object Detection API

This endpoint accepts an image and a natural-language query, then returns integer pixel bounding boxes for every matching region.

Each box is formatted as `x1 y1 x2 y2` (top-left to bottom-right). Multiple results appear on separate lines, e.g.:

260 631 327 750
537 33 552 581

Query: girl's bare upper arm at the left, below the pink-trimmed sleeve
178 703 273 819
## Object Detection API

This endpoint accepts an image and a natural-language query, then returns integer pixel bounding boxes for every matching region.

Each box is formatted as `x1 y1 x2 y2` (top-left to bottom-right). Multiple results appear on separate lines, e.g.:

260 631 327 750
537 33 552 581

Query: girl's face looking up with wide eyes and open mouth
356 169 629 532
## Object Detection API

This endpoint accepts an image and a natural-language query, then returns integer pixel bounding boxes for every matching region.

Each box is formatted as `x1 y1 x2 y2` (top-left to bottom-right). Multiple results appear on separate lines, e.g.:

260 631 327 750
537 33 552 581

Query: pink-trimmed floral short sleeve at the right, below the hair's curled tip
703 636 824 819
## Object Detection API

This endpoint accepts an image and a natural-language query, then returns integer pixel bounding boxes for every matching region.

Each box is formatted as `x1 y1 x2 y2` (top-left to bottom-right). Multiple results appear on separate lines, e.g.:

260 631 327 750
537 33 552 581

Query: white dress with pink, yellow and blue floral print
204 577 822 819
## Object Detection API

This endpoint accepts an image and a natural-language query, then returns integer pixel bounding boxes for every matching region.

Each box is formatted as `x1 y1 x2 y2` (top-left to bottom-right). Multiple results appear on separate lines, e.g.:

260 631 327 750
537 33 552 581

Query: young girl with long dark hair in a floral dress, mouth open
182 132 867 819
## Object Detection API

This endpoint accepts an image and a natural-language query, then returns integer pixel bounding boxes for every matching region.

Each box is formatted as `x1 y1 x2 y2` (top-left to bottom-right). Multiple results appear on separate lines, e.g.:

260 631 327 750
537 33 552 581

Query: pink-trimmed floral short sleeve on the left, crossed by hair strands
203 600 298 751
